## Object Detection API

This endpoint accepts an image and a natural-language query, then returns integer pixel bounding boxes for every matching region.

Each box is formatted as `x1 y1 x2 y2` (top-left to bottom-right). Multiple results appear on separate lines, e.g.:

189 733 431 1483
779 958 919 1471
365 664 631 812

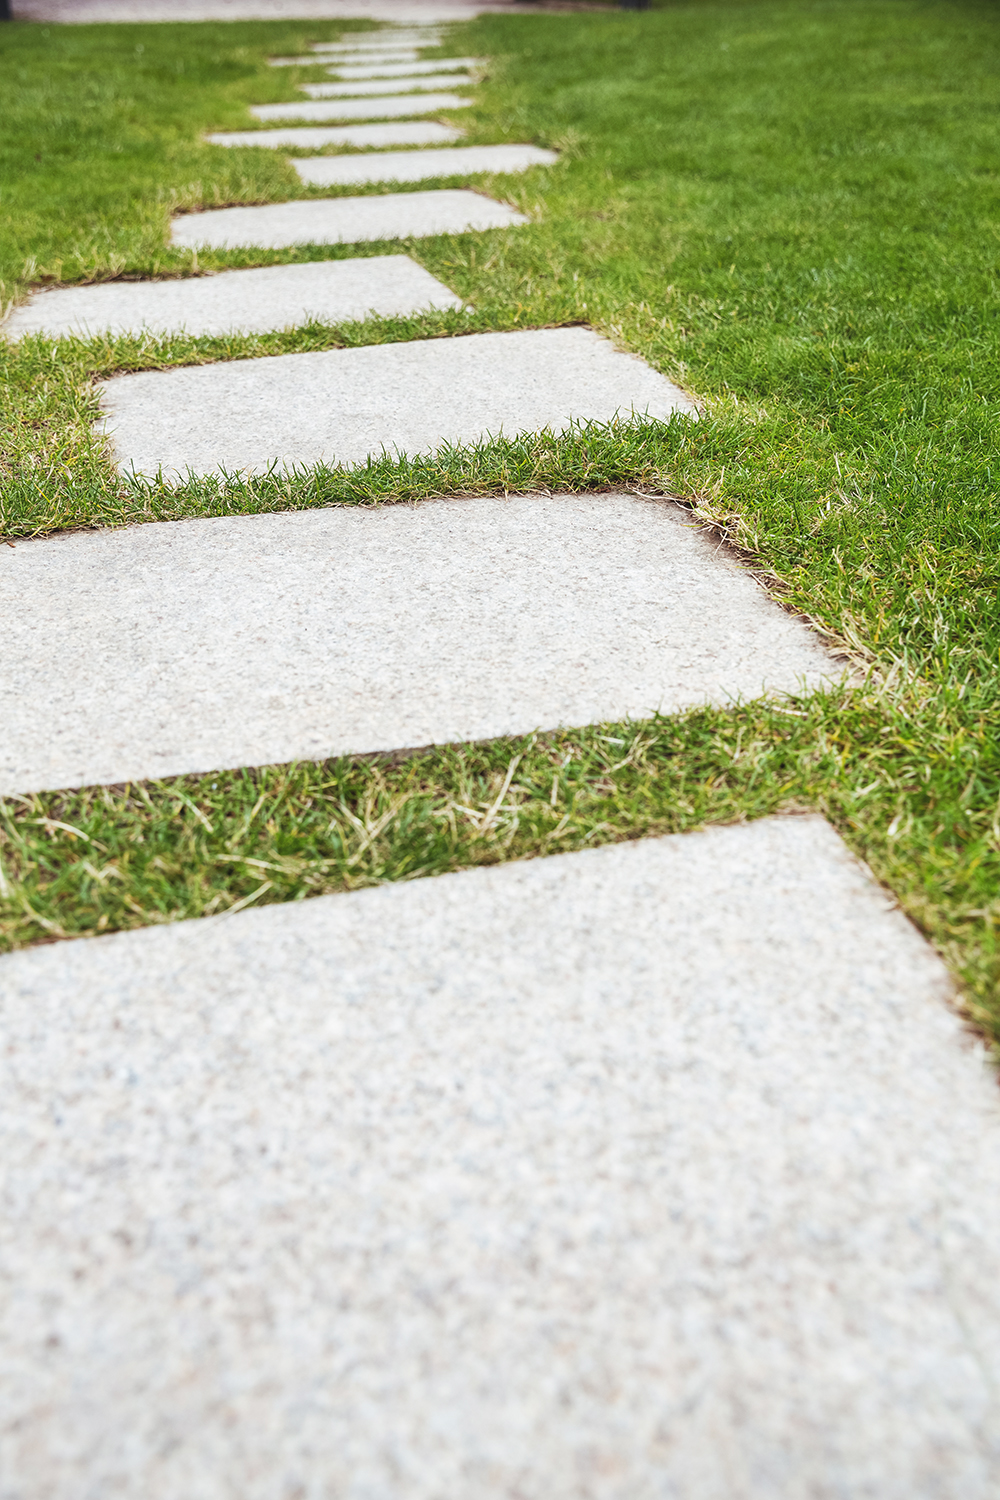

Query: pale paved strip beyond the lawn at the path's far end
12 0 523 17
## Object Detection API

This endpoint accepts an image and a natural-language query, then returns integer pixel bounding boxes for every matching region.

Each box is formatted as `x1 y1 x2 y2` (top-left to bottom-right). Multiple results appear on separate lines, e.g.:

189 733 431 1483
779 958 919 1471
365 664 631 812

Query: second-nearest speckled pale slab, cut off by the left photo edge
0 492 844 795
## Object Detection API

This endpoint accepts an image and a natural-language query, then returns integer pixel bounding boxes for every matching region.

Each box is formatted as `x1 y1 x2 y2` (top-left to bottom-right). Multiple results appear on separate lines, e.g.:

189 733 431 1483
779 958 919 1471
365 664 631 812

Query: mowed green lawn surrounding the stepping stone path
0 0 1000 1040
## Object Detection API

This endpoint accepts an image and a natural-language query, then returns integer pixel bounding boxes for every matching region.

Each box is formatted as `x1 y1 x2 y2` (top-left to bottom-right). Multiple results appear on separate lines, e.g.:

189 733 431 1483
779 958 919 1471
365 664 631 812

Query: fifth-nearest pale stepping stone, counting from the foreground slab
171 190 528 251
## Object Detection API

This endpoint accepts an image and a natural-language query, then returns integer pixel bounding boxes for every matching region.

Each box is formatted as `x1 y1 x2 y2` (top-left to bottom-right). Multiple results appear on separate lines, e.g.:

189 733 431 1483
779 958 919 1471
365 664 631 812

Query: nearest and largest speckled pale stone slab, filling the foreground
0 819 1000 1500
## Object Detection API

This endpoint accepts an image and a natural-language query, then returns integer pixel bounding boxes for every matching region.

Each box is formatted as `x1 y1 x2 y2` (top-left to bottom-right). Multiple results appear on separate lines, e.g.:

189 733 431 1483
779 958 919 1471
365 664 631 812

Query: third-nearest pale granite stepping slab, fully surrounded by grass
100 328 694 477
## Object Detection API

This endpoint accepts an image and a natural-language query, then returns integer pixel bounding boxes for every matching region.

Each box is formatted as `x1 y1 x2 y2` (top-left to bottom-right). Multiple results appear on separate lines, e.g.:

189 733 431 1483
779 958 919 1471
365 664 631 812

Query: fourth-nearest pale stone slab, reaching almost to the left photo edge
3 255 462 338
